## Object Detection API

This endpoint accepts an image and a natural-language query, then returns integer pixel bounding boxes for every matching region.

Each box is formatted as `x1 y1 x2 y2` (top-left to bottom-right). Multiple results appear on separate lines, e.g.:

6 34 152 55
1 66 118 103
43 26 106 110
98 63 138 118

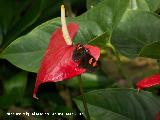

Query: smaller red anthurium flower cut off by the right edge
136 74 160 90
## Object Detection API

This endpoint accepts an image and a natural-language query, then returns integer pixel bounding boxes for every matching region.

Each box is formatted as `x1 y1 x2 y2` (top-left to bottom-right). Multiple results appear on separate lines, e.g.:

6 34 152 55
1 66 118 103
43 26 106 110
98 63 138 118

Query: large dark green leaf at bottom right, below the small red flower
75 89 160 120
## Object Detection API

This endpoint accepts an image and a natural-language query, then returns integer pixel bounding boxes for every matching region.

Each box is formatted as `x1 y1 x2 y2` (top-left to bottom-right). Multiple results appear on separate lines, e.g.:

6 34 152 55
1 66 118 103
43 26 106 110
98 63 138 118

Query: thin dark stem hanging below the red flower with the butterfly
78 75 90 120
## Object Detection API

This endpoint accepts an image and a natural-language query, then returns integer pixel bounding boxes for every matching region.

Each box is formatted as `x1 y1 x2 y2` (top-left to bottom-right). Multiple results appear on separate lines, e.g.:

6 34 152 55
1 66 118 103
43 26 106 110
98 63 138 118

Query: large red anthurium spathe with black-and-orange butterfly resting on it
33 23 100 98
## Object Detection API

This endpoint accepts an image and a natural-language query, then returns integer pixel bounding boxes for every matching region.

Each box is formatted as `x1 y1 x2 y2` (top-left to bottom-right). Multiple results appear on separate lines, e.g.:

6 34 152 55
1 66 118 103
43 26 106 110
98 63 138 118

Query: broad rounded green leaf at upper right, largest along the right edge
112 10 160 57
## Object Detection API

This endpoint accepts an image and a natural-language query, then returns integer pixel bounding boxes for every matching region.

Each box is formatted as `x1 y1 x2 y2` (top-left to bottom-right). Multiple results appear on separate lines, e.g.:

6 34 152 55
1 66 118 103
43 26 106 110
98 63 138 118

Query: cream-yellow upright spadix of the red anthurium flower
61 5 72 45
